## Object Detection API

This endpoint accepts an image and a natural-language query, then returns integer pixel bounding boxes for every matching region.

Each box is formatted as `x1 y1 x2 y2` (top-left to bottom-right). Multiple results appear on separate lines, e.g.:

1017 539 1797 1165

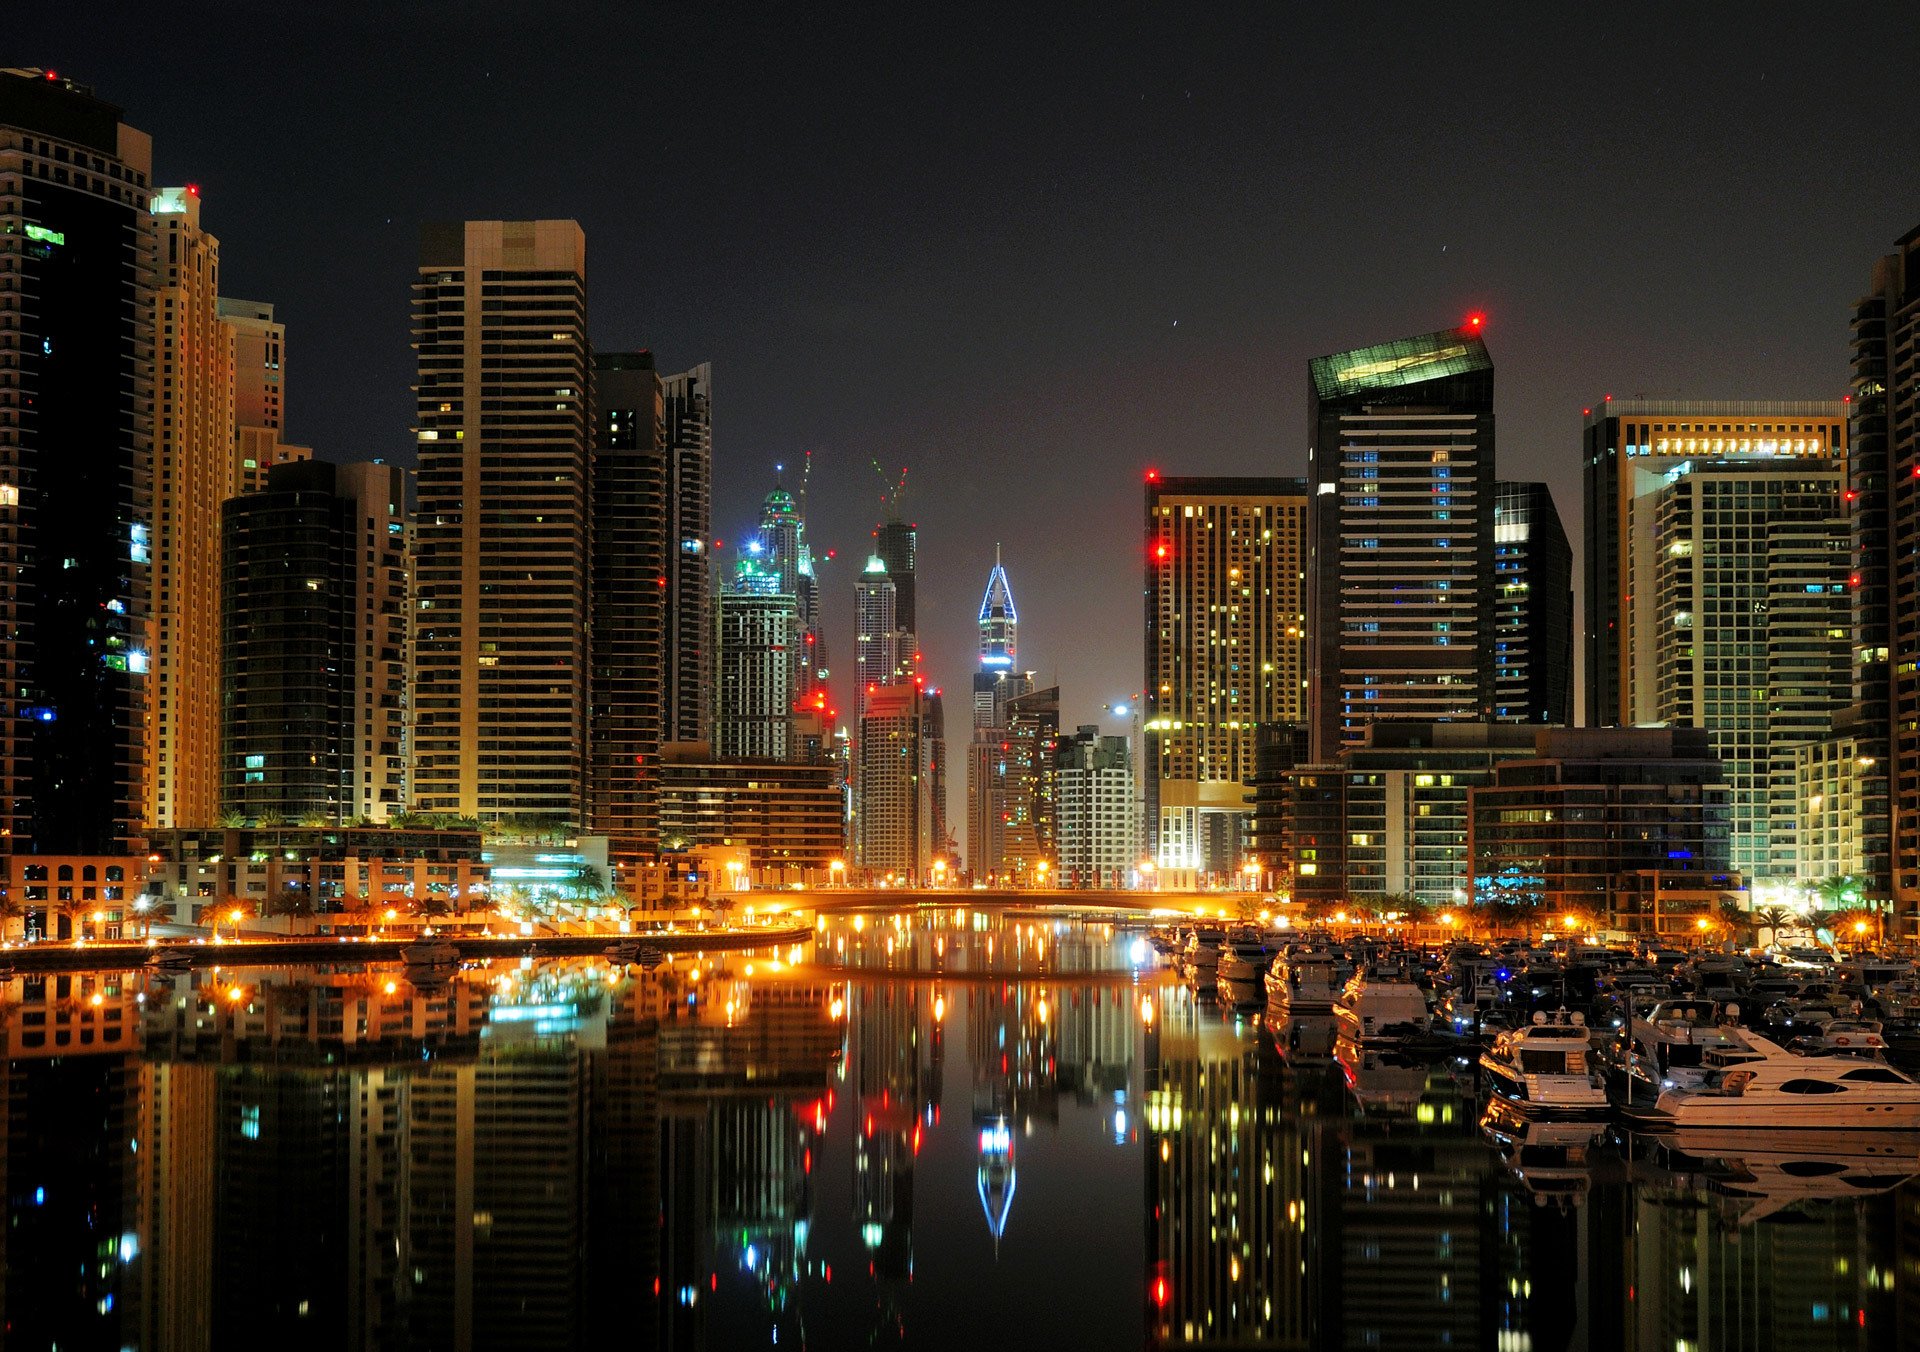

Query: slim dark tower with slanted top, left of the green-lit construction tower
660 361 714 741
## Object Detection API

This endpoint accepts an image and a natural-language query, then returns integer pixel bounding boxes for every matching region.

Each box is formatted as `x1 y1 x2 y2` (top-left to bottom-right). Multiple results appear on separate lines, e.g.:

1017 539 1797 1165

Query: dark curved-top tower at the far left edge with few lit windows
0 69 153 855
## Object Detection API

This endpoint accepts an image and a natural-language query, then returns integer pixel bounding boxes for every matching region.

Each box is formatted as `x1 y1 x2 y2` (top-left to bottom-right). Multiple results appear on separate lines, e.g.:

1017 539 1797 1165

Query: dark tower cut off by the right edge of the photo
1847 229 1920 917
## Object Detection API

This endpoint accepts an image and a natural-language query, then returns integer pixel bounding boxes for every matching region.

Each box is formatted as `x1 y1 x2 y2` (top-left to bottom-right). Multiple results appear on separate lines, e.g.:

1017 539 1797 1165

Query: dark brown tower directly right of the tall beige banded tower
588 351 680 862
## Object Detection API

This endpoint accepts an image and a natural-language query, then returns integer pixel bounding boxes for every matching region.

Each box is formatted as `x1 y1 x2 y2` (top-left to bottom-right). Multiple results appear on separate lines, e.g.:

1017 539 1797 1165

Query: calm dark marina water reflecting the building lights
0 912 1920 1352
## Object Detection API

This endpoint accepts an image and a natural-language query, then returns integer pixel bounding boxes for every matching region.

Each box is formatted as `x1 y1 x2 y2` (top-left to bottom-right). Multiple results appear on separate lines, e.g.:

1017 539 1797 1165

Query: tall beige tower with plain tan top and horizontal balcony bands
413 221 579 824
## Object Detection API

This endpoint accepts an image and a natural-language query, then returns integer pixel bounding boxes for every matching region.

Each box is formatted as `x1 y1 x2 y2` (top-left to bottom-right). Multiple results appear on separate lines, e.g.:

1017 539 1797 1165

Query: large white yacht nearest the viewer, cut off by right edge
1653 1033 1920 1131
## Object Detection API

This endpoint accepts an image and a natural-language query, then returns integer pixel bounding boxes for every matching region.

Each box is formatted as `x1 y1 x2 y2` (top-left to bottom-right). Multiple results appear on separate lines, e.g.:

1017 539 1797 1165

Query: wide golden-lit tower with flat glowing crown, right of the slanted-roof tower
1586 399 1853 880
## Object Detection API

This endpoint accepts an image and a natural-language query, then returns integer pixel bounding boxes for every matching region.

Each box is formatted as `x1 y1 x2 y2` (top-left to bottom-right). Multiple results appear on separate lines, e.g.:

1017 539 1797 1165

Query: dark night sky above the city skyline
26 0 1920 756
